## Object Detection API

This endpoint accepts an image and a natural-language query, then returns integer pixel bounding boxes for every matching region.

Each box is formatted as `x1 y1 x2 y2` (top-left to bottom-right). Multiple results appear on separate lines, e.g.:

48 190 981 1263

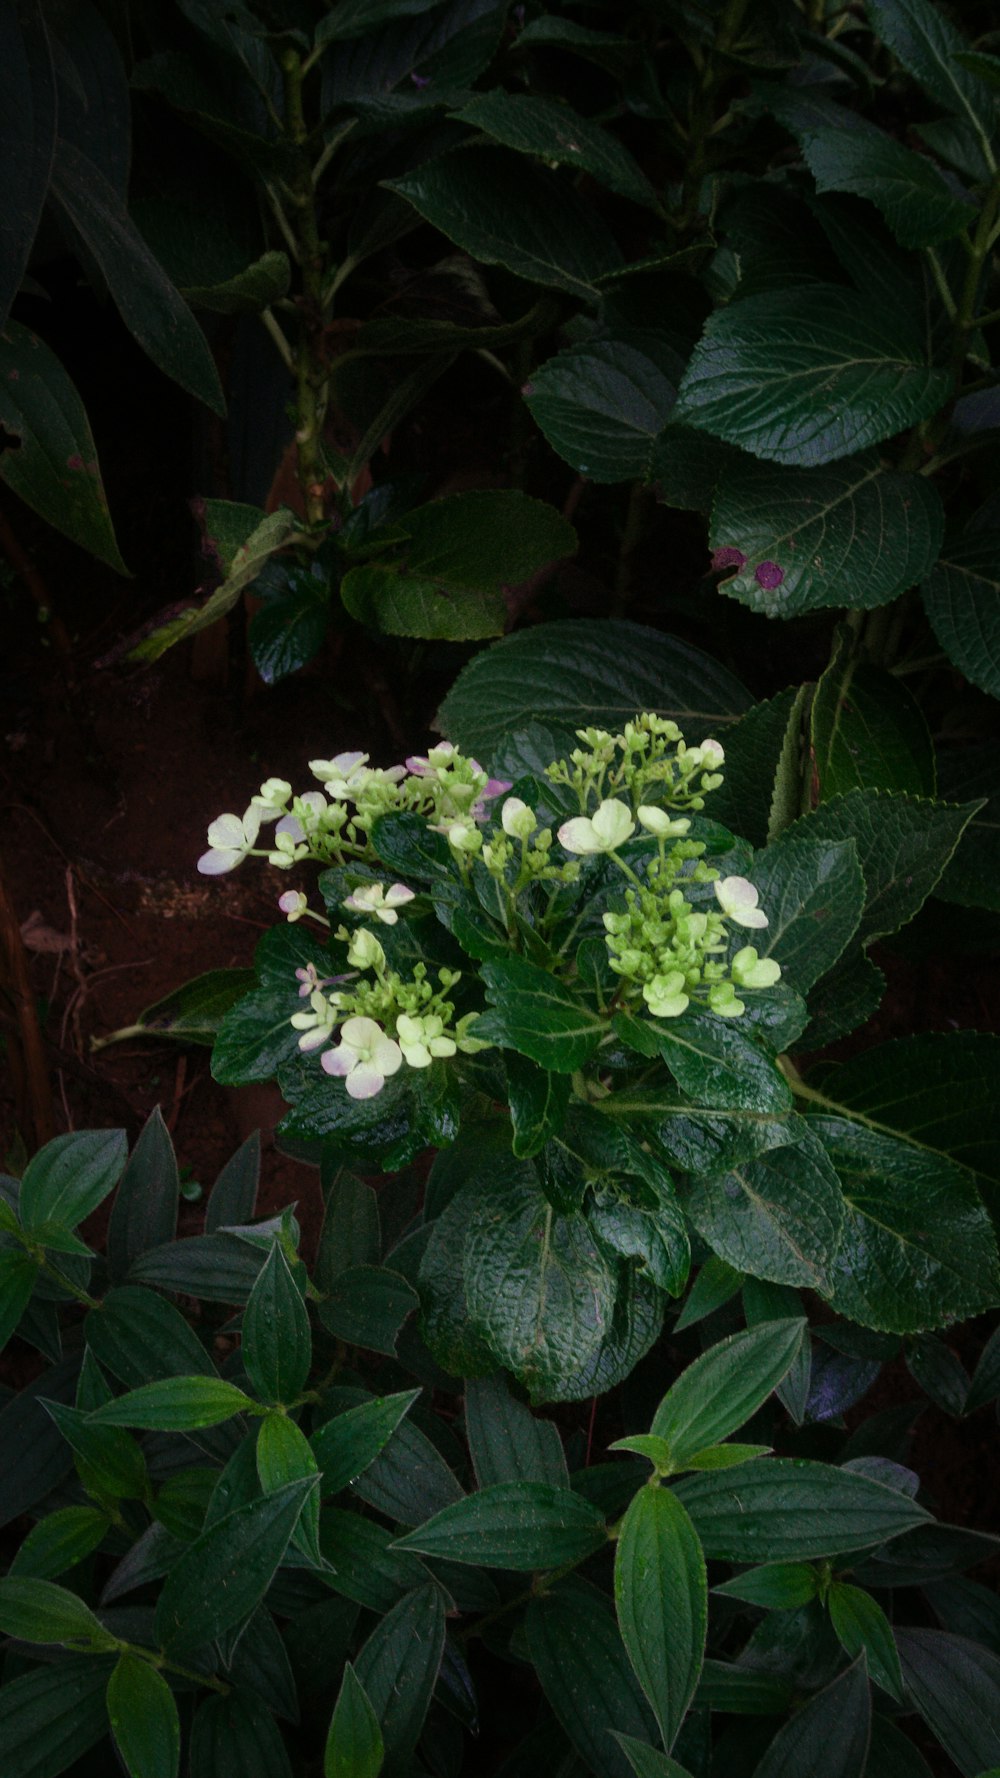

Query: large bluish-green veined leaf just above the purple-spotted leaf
673 284 952 468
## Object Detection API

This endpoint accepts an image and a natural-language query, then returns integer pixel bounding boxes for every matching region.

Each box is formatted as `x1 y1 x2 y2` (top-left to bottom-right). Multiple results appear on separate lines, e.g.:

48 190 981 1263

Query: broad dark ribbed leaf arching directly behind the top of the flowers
441 619 751 763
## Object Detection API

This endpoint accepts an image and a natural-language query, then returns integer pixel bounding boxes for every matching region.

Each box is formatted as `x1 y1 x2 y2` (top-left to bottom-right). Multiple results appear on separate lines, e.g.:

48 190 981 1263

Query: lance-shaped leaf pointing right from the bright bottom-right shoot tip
674 1458 929 1563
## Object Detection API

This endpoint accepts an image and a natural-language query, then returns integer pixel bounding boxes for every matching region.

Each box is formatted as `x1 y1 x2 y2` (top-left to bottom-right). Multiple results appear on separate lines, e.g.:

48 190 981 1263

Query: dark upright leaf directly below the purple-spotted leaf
810 640 932 803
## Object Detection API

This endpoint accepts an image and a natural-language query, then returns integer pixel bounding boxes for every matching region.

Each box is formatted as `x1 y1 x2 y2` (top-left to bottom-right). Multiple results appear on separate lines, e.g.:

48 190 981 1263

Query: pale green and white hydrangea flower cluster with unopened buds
198 713 781 1099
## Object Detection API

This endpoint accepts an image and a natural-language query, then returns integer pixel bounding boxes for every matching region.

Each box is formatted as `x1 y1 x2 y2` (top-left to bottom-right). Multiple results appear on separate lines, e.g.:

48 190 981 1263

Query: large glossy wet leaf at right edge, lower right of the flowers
810 1116 1000 1334
